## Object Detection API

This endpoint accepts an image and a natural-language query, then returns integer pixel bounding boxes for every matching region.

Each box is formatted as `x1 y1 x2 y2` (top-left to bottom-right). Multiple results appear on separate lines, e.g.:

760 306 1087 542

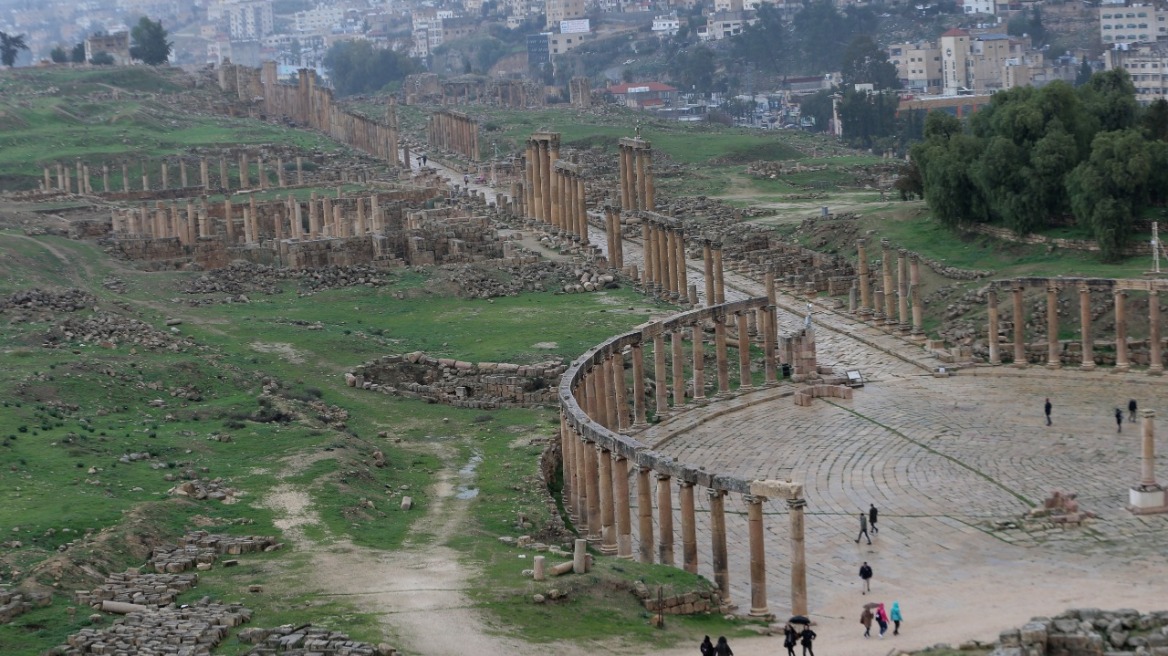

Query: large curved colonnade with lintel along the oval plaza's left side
559 295 807 616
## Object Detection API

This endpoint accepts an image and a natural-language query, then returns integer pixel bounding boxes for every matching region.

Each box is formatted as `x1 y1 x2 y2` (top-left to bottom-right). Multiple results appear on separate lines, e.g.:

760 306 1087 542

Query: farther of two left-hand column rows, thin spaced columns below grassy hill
42 152 313 194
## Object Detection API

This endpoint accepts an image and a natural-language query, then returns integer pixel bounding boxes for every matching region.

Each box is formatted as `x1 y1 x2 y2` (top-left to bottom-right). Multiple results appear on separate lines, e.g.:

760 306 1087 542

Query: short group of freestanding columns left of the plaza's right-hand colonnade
853 239 924 339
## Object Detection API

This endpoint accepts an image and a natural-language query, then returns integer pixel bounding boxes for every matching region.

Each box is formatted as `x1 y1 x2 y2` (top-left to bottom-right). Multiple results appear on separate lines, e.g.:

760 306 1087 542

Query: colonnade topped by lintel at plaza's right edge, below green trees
986 278 1168 375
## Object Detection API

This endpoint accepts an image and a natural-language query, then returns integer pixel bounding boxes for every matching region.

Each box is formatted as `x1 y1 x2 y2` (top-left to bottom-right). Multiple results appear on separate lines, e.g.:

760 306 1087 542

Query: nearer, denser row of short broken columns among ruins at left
112 193 385 245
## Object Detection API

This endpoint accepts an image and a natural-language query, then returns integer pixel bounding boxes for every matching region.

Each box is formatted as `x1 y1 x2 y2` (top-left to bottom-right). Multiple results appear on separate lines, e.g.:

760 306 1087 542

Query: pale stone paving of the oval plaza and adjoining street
418 151 1168 654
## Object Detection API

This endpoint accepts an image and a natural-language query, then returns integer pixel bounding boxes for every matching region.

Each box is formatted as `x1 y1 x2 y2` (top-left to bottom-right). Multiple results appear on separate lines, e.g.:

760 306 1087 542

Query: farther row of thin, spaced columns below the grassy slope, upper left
41 153 313 194
